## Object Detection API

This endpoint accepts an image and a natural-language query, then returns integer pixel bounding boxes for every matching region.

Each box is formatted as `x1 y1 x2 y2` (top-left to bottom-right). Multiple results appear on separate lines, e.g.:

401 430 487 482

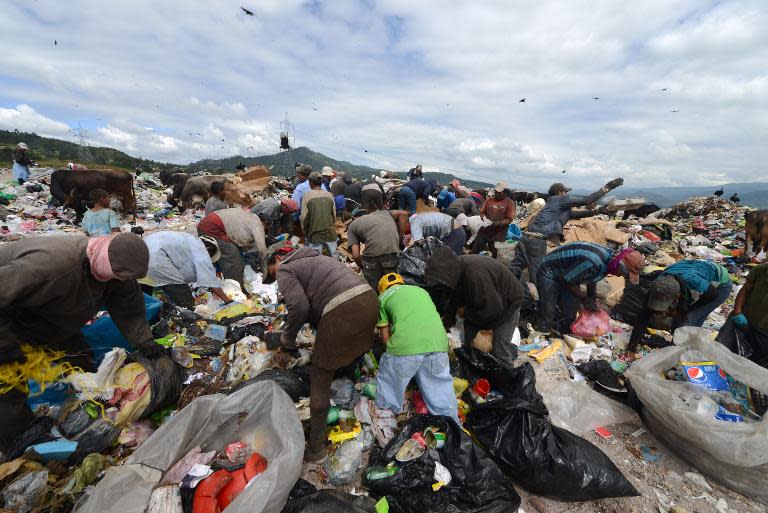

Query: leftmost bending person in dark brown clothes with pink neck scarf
0 233 160 453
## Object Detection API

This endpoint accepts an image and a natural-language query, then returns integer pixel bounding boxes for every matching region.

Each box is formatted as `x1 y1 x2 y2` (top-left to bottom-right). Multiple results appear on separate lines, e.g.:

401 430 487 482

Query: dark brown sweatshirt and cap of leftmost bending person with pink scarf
0 233 152 351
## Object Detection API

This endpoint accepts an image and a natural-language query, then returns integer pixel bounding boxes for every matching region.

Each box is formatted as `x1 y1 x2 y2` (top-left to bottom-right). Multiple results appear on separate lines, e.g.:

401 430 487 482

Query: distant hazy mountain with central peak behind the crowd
188 146 491 189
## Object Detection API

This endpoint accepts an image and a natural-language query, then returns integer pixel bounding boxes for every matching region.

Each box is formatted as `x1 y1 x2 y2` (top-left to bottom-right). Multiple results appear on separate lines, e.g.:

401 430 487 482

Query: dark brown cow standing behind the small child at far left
51 169 136 220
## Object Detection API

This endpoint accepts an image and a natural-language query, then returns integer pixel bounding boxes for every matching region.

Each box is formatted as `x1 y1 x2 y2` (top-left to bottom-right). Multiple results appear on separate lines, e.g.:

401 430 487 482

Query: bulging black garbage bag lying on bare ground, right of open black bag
456 349 638 501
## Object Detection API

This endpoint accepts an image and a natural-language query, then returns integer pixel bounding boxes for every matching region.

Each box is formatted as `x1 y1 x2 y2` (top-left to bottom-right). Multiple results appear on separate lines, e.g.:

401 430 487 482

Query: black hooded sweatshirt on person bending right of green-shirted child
424 247 525 329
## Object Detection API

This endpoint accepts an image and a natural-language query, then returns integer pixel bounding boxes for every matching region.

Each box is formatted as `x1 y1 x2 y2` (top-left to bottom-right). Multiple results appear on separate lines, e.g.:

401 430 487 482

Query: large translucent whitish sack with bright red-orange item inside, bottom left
74 381 304 513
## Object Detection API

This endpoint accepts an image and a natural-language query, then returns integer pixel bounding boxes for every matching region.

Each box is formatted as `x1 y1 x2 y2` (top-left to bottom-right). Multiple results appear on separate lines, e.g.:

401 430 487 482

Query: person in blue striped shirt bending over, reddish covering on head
536 242 645 333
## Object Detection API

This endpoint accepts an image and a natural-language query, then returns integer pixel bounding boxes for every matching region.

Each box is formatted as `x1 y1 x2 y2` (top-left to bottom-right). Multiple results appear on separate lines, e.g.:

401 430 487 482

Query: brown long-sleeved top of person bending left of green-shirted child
277 247 371 338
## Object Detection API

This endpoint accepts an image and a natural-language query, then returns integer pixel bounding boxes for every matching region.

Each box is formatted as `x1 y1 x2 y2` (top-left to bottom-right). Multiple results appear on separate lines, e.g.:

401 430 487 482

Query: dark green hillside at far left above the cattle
0 130 178 171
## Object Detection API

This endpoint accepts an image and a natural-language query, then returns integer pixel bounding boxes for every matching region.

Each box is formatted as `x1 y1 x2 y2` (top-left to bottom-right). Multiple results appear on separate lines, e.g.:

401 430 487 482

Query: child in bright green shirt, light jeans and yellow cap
376 273 461 425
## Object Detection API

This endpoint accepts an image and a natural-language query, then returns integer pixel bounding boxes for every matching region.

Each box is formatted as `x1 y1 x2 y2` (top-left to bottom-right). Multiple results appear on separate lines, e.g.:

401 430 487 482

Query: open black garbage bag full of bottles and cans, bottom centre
365 415 520 513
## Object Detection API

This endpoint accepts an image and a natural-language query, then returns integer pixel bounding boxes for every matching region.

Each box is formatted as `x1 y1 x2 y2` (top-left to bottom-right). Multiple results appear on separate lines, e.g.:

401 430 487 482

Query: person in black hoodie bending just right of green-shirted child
424 247 525 363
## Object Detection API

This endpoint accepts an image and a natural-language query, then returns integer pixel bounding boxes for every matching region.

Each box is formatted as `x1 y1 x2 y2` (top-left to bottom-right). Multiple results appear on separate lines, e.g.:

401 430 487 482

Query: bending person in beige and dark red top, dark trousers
197 208 267 288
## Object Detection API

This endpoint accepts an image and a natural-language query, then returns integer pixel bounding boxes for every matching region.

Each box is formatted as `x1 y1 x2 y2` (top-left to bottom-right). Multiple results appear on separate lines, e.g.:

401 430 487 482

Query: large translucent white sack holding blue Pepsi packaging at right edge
625 327 768 503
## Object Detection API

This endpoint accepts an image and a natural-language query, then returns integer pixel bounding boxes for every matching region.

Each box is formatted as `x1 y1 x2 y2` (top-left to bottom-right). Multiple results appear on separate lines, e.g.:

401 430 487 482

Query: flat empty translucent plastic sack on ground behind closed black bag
536 380 640 435
